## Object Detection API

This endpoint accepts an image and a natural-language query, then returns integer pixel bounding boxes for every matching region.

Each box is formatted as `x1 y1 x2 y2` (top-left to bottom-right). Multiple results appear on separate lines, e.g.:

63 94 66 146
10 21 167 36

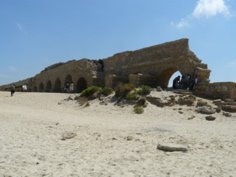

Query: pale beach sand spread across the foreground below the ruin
0 92 236 177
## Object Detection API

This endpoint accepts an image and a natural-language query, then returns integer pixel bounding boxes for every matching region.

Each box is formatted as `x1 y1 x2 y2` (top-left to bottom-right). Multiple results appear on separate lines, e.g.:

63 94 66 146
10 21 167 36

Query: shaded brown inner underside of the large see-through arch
158 68 181 88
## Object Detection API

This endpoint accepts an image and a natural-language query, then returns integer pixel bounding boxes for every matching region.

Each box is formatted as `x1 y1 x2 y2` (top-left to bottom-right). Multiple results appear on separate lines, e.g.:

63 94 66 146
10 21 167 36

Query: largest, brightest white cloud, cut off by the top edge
192 0 230 18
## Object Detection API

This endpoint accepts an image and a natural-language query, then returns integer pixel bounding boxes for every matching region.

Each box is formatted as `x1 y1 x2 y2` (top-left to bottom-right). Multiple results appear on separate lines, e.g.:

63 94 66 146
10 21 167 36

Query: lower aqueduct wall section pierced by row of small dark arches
30 59 104 92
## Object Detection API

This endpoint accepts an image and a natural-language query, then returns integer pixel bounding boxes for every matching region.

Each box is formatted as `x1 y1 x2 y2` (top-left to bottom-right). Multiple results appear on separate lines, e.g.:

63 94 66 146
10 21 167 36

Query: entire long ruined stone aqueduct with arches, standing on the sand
0 39 235 97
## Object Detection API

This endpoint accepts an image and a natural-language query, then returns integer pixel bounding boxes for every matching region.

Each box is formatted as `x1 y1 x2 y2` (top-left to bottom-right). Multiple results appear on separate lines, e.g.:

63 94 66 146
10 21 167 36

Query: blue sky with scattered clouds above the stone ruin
0 0 236 85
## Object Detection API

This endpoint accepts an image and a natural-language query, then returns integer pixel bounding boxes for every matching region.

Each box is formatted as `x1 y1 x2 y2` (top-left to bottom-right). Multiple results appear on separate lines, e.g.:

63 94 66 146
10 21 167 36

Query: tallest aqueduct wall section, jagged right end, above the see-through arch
104 39 210 87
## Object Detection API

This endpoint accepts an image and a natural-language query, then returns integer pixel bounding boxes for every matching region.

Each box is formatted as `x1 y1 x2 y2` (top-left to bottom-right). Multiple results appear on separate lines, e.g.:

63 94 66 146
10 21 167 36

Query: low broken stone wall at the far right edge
194 82 236 100
